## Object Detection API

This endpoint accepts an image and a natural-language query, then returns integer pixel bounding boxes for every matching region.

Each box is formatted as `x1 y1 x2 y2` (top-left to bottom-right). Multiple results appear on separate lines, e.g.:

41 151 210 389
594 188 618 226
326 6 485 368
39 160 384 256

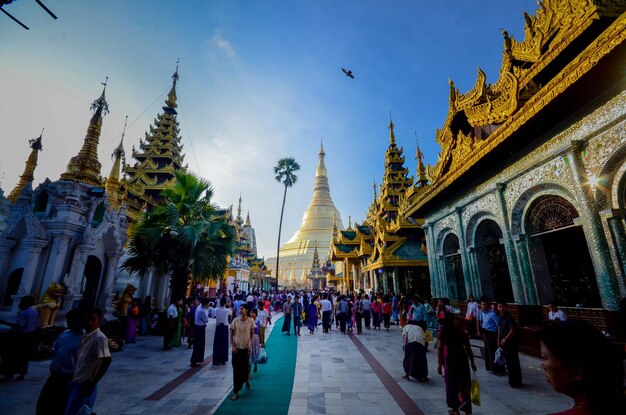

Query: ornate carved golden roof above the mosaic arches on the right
402 0 626 216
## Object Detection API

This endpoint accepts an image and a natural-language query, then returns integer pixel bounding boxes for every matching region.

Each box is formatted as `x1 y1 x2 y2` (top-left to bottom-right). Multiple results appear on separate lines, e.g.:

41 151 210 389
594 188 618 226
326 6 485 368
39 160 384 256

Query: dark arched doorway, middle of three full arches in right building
474 219 515 303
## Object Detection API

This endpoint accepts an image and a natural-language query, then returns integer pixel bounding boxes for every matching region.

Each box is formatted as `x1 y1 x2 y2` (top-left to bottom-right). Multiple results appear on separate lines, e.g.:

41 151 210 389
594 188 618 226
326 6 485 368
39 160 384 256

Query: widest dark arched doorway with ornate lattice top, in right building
525 195 601 307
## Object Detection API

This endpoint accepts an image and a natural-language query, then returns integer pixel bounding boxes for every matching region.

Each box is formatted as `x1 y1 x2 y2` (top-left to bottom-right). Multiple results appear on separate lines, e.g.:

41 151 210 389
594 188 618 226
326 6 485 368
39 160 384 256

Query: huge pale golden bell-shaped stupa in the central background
274 145 343 288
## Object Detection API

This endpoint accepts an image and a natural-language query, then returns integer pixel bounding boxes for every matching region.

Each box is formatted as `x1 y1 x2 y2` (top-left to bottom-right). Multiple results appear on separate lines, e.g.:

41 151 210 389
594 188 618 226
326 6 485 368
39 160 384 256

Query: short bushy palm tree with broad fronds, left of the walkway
122 172 235 299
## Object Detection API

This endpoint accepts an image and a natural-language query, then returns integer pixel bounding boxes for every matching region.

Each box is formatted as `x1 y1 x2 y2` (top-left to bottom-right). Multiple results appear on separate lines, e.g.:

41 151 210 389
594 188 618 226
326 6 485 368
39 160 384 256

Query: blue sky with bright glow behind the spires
0 0 535 257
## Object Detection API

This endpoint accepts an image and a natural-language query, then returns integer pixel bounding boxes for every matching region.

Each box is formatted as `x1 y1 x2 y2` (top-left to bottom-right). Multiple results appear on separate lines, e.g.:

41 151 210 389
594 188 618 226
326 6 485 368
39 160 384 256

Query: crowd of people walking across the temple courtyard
0 291 624 415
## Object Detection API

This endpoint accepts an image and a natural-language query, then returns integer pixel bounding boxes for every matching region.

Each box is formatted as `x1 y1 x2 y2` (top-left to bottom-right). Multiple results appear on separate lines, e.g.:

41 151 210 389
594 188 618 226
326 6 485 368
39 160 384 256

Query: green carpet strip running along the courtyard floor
215 317 298 415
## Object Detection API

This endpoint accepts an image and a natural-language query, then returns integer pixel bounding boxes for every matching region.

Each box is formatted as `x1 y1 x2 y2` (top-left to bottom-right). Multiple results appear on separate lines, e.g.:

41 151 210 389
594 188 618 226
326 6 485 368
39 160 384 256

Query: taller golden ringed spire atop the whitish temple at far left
61 76 109 186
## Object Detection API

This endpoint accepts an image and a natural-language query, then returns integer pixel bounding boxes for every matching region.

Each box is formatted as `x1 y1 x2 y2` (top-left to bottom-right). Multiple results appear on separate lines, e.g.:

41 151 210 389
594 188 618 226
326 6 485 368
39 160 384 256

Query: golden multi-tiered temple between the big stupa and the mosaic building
331 119 430 297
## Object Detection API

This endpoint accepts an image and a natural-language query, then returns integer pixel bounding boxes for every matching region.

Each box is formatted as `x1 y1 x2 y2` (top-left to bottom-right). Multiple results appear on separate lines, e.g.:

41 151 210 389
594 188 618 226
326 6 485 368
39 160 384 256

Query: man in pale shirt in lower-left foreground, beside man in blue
65 308 111 415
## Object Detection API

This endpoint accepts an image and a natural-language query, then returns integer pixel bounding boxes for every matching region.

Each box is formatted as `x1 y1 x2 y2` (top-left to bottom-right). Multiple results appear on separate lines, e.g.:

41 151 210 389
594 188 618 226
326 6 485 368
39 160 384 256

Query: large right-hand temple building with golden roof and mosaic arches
400 0 626 330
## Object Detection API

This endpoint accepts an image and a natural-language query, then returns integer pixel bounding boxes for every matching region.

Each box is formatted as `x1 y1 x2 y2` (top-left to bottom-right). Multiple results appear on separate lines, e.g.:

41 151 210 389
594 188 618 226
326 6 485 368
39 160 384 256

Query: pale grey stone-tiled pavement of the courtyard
0 321 571 415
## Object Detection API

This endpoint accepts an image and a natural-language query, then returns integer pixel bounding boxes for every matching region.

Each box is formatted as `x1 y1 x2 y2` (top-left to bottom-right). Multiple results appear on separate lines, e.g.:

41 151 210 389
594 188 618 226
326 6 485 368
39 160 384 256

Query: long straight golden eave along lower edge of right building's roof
406 8 626 216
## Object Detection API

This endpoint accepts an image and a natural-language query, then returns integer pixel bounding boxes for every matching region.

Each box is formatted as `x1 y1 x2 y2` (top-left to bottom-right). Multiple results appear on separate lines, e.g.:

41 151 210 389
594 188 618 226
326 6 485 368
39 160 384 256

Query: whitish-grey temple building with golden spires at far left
0 83 127 325
